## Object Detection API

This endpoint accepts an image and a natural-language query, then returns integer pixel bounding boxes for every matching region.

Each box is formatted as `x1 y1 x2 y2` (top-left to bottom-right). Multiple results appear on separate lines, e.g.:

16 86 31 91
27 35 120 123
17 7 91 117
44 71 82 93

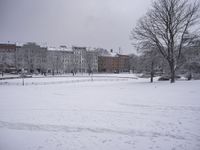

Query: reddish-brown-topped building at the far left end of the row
0 44 16 72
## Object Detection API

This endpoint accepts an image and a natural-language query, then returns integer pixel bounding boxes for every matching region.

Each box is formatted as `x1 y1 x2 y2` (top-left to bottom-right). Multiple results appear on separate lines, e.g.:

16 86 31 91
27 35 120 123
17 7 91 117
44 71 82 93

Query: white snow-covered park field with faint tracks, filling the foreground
0 75 200 150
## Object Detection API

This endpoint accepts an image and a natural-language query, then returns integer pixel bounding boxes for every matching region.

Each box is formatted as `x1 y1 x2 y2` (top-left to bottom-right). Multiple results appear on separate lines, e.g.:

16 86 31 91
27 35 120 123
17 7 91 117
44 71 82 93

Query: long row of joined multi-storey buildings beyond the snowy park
0 42 130 74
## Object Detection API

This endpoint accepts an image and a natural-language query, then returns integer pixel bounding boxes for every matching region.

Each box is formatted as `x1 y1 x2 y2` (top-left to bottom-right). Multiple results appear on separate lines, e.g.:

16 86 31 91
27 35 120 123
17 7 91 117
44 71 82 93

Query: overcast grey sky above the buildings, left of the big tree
0 0 152 53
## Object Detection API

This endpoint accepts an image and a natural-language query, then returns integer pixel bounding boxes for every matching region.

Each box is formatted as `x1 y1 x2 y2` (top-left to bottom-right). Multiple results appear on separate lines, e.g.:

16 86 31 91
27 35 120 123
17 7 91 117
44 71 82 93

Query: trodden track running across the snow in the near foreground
0 121 185 140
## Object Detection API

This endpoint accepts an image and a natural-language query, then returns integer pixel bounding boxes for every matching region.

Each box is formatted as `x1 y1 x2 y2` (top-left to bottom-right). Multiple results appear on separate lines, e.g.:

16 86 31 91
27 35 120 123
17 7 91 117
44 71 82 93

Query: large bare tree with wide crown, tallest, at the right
131 0 200 83
